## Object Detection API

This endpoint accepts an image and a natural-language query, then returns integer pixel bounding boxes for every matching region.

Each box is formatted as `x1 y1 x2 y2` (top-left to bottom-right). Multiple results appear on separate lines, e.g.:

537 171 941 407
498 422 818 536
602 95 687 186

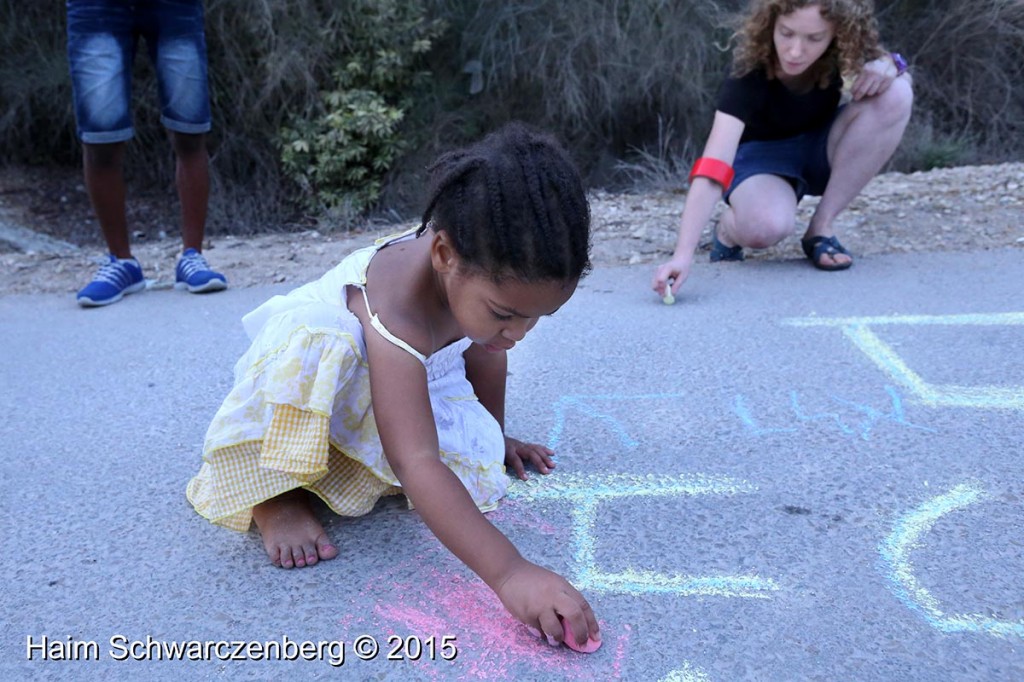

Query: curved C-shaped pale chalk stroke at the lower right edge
879 483 1024 637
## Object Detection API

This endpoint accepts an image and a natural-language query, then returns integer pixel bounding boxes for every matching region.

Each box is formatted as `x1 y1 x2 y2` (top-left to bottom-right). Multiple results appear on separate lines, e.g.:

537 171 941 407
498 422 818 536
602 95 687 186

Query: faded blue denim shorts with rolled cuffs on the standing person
68 0 210 144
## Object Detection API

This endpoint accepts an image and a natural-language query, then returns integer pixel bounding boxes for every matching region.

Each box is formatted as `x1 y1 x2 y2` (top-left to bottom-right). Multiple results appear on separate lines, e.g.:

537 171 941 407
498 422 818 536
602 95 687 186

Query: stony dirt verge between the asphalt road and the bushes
0 163 1024 295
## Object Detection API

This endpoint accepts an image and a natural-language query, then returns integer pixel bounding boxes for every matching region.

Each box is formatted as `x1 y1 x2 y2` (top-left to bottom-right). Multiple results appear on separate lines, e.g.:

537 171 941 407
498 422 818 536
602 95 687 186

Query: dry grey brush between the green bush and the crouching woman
425 0 728 181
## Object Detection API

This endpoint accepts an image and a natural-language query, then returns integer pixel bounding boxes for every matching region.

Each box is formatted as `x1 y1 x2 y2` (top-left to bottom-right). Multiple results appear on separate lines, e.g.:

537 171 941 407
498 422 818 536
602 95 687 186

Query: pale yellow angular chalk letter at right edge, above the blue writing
782 312 1024 410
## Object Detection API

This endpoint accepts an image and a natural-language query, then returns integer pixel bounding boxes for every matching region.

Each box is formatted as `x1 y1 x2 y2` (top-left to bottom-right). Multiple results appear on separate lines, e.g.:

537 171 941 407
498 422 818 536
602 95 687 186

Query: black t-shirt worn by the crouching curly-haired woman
717 69 843 142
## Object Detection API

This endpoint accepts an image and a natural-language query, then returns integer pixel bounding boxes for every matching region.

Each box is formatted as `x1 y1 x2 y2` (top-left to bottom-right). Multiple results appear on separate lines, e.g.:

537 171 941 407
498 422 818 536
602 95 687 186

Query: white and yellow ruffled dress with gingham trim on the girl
186 232 509 531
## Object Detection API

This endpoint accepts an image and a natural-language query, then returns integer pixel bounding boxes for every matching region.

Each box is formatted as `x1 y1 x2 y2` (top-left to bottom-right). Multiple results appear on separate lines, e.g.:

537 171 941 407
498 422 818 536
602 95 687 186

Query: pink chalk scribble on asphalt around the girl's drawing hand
342 548 630 680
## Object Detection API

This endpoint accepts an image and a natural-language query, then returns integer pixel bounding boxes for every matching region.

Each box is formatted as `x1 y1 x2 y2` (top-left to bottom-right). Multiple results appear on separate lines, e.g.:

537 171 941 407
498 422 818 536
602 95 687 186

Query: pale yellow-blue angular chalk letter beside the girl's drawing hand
509 474 779 599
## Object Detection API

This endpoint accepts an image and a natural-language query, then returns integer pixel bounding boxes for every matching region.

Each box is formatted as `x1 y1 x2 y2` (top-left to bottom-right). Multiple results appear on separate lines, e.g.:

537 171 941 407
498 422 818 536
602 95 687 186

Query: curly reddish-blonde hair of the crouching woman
732 0 885 87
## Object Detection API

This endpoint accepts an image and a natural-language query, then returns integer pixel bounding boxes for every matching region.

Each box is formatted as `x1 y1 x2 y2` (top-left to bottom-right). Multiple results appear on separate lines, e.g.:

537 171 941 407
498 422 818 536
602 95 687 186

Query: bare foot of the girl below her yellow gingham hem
253 489 338 568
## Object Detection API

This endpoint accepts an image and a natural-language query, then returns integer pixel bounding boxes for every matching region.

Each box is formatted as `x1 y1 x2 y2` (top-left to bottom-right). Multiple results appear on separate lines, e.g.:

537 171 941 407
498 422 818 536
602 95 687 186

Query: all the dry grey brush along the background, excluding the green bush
0 0 1024 220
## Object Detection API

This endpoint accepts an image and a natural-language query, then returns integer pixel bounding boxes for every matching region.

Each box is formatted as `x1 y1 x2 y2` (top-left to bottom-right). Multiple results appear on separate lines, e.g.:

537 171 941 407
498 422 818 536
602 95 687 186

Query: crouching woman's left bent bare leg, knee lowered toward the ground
718 174 797 249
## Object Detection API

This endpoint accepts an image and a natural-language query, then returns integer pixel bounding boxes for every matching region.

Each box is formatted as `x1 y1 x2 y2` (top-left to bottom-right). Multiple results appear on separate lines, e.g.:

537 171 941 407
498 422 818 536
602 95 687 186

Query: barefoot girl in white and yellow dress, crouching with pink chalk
187 124 600 649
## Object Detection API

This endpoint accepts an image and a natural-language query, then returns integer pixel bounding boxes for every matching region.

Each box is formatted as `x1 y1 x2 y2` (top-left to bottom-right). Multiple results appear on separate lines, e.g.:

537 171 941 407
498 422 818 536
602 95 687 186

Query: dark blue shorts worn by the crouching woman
724 106 843 202
